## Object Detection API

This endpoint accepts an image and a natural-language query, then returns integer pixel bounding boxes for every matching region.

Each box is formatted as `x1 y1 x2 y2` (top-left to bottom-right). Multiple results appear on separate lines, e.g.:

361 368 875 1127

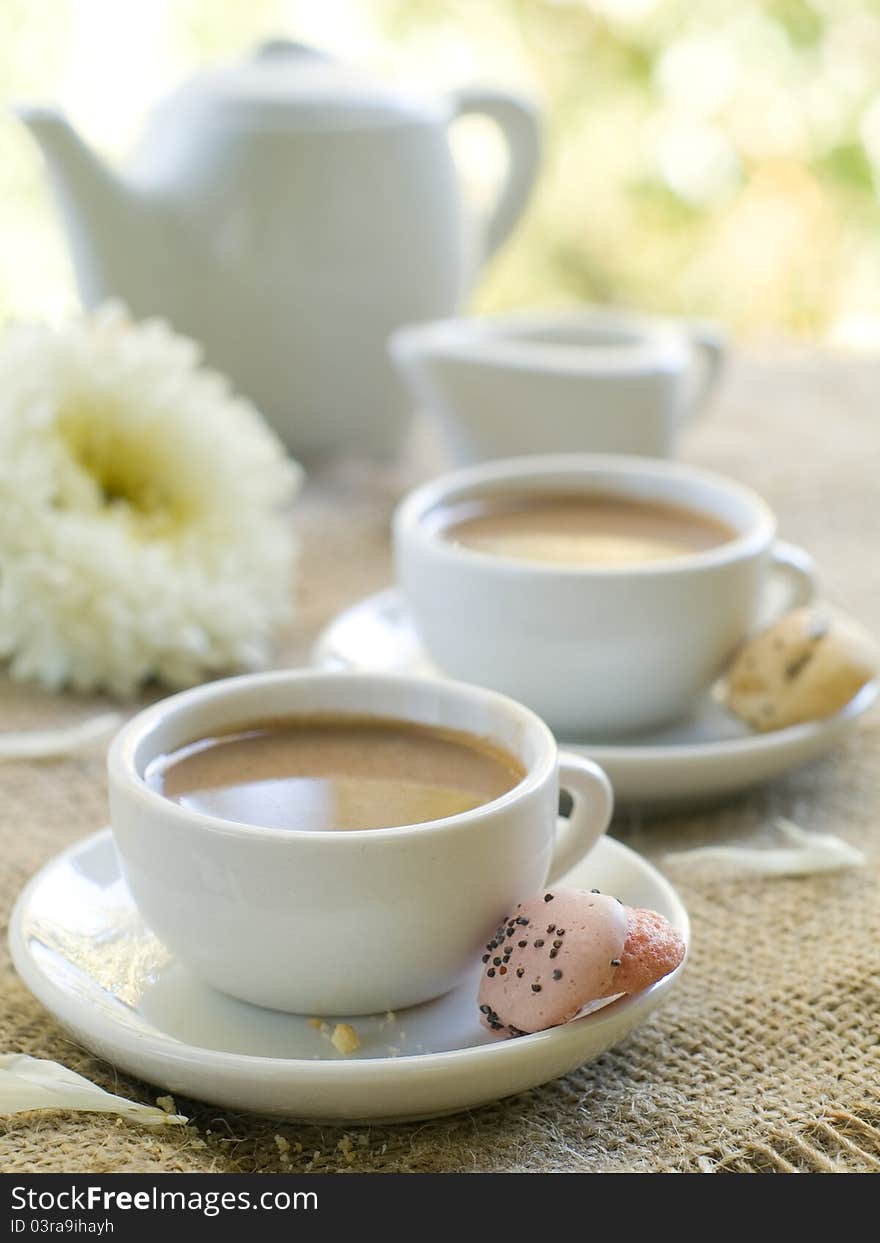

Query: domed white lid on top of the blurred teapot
163 39 446 131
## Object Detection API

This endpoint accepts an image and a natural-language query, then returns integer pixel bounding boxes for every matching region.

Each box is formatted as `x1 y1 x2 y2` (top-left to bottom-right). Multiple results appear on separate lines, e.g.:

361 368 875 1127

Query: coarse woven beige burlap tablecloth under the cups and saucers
0 352 880 1172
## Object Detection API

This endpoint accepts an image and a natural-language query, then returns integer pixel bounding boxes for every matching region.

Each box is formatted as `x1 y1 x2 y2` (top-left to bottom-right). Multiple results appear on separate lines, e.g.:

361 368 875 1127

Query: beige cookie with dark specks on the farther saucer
718 607 879 732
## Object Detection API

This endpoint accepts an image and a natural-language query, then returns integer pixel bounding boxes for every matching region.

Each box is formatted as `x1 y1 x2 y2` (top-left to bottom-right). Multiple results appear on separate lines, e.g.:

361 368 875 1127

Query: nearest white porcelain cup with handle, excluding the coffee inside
108 670 612 1016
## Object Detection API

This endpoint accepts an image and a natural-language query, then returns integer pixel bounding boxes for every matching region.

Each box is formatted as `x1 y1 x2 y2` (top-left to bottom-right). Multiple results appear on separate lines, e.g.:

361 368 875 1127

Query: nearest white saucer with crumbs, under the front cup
9 829 689 1122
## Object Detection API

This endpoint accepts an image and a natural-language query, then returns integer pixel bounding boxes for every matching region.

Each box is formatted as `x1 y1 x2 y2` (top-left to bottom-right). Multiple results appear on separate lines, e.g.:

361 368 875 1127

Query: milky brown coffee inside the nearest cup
144 715 526 833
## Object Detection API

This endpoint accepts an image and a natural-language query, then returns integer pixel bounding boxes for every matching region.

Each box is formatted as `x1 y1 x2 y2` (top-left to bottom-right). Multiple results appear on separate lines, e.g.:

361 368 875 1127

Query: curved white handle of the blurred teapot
451 87 541 259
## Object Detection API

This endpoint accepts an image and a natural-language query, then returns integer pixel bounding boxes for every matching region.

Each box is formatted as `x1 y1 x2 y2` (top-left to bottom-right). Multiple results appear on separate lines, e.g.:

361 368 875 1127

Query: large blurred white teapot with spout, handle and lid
17 40 539 461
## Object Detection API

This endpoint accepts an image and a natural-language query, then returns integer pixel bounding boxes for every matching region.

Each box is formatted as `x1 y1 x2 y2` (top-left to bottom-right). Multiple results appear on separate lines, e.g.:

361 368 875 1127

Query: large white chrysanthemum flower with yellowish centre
0 303 301 695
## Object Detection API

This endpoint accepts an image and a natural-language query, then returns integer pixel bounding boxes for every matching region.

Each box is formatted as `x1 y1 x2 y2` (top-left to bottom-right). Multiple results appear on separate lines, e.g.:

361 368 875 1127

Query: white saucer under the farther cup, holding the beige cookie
312 589 878 812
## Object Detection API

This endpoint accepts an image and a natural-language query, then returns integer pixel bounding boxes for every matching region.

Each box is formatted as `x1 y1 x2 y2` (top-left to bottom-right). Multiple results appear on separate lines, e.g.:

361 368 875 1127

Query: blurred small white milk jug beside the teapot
389 310 723 465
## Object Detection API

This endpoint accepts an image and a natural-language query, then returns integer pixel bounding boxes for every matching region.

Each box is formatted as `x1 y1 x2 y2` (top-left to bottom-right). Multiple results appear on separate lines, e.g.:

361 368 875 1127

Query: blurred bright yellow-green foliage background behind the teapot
0 0 880 346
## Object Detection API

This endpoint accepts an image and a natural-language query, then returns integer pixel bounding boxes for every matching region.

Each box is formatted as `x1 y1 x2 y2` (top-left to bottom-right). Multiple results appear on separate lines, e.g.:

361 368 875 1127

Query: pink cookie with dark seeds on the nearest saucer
479 889 685 1035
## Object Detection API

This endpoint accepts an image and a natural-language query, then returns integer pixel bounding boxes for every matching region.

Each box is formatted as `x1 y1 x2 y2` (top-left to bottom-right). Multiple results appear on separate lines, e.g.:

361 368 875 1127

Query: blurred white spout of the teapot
14 104 133 306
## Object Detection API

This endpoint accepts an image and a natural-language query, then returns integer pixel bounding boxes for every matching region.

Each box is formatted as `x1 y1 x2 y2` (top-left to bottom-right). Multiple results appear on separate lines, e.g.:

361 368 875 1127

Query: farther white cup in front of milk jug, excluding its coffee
394 454 813 741
